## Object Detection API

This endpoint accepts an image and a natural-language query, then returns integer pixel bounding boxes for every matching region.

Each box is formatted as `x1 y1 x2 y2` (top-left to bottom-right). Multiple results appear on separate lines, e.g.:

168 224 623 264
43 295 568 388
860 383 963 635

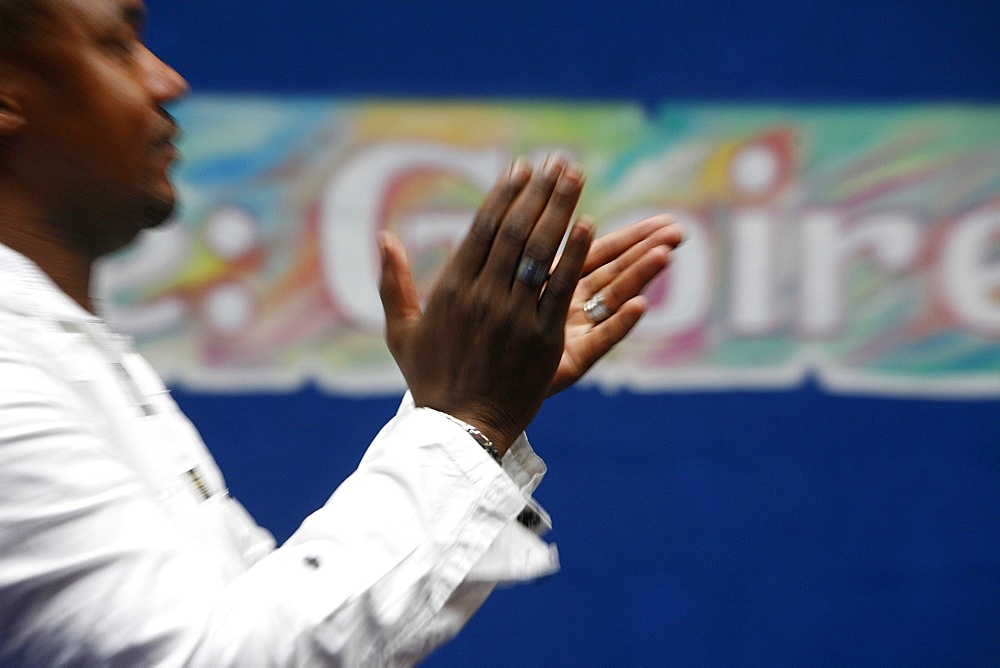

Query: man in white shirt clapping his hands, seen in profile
0 0 680 666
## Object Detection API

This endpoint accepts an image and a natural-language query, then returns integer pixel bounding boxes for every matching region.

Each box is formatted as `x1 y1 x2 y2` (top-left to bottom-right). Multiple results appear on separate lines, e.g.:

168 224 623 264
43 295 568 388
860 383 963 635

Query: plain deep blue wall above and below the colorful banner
147 0 1000 666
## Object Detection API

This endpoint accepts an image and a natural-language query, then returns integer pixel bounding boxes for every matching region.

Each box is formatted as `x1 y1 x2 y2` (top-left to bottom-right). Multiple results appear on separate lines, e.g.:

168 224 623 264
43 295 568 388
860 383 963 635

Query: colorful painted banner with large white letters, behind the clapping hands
98 96 1000 396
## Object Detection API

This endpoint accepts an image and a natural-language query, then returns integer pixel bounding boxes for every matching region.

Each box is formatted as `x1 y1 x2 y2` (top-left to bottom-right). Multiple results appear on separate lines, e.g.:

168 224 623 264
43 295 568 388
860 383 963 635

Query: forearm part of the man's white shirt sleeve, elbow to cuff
185 400 557 665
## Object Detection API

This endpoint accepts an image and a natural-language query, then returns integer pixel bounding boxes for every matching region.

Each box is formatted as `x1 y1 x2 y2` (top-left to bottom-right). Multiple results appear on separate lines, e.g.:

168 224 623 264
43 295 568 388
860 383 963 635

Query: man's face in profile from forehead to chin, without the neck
5 0 187 258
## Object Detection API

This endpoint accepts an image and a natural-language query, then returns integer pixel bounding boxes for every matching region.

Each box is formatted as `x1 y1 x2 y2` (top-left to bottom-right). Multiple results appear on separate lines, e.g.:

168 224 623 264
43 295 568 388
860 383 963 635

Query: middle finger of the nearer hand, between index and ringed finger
483 153 566 286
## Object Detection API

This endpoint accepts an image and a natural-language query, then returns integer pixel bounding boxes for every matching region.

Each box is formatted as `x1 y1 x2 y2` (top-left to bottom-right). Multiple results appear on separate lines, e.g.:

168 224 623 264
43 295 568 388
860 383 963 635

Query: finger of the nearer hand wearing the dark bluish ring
512 163 584 300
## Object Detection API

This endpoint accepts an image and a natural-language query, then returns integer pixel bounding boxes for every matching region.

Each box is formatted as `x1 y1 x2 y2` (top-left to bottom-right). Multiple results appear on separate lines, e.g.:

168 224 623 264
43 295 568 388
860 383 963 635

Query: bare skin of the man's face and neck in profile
0 0 187 310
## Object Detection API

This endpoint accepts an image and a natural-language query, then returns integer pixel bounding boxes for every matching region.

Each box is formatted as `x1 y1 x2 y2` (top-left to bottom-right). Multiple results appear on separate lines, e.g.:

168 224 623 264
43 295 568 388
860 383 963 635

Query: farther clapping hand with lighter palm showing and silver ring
550 214 684 395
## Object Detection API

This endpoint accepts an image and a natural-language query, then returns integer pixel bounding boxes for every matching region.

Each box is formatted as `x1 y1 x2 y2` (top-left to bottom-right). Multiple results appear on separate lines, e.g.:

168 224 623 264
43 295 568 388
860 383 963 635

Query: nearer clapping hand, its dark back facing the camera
378 155 592 454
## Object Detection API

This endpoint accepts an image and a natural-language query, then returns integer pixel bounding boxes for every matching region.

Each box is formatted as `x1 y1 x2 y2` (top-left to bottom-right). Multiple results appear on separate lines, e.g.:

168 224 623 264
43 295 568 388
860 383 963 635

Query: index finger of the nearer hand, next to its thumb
447 158 531 280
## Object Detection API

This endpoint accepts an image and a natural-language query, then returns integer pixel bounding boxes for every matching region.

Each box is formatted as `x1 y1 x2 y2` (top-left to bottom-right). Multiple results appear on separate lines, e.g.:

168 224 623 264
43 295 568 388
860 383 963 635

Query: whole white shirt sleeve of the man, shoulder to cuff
0 347 558 666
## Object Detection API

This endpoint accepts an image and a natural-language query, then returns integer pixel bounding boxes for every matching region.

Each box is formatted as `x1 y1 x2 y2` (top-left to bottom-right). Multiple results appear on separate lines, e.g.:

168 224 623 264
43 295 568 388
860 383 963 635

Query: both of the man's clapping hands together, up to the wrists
379 156 682 454
